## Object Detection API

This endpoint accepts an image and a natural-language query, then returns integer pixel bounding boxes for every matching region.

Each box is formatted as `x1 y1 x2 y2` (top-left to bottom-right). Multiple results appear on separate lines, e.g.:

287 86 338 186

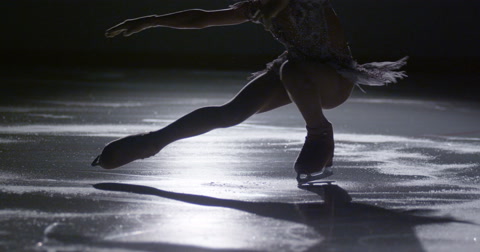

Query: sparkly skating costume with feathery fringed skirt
232 0 407 86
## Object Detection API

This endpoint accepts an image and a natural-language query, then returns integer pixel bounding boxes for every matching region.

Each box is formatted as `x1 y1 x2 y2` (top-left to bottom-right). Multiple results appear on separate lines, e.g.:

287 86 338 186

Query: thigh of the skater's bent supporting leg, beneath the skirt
281 60 354 109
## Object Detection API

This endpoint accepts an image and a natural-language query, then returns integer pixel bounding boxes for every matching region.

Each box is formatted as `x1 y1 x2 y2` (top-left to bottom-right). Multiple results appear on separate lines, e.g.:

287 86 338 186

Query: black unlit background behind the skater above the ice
0 0 480 95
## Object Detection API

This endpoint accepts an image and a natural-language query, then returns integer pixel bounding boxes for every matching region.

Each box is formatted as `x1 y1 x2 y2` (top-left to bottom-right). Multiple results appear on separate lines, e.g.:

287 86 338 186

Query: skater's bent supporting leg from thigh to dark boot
281 61 353 179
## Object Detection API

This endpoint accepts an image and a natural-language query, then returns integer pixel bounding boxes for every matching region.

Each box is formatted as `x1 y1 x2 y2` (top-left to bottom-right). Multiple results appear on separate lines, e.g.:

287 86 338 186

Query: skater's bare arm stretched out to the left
105 6 248 38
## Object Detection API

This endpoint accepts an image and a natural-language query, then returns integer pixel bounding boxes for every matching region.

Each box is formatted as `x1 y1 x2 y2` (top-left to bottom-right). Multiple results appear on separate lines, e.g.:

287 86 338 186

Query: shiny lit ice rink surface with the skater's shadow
0 69 480 252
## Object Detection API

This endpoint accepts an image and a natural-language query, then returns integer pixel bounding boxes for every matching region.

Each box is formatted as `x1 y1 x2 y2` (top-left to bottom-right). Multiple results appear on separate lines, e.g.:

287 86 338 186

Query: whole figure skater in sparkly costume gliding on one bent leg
92 0 407 184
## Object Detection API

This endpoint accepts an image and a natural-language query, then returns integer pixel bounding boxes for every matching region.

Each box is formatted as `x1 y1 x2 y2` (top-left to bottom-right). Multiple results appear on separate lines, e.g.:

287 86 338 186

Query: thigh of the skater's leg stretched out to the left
225 71 291 114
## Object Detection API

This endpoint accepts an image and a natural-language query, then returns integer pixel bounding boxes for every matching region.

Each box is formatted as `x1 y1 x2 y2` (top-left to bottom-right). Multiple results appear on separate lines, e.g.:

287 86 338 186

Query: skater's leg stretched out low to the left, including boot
92 72 290 169
